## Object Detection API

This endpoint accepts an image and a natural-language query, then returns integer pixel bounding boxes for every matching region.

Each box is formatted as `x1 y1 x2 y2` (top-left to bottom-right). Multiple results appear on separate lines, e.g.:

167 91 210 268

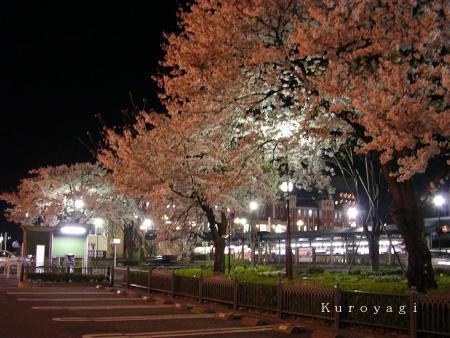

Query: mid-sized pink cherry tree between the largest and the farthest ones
98 112 270 273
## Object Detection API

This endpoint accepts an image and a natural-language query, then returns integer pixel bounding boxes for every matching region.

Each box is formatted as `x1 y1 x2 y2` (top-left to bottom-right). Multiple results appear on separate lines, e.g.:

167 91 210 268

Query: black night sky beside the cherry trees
0 0 184 240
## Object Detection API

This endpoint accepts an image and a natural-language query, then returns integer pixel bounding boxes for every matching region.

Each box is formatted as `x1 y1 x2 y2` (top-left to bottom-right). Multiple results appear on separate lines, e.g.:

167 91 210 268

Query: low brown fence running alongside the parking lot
117 268 450 337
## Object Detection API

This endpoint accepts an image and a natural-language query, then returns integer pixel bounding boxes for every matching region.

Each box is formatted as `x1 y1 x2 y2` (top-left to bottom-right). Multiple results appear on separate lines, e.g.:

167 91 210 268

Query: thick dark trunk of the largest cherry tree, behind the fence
382 161 437 292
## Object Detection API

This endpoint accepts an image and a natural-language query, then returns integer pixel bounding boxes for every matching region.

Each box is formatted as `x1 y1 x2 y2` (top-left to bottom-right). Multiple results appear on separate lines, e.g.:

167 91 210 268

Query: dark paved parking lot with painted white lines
0 286 300 338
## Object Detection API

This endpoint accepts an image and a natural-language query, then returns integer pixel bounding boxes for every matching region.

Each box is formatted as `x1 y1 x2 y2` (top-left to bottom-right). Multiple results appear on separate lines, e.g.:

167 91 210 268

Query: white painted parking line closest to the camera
82 325 272 338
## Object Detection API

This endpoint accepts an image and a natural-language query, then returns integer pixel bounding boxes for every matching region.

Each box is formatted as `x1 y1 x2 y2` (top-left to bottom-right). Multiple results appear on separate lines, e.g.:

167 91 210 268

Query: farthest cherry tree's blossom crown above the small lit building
0 163 144 240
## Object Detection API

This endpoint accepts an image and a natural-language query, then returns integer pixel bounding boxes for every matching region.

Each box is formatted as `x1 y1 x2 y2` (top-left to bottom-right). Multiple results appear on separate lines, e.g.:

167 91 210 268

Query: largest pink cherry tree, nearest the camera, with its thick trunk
157 0 450 291
